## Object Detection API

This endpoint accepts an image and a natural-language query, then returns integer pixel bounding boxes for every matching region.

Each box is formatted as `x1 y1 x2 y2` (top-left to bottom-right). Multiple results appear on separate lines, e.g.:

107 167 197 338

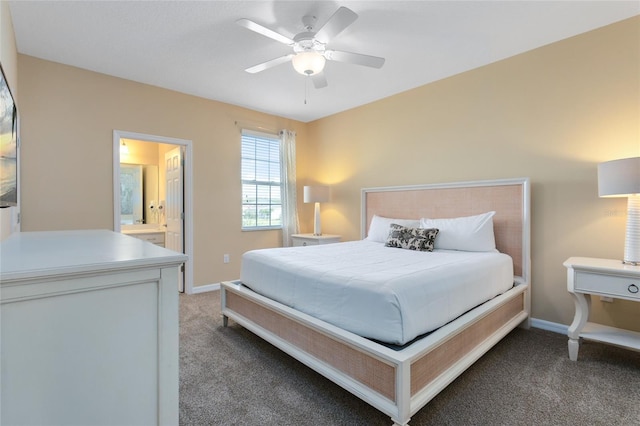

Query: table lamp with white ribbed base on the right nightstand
598 157 640 265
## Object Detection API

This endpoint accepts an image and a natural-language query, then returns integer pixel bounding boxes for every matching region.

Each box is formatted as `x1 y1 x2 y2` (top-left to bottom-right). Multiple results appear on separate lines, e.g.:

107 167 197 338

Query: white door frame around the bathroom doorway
113 130 193 294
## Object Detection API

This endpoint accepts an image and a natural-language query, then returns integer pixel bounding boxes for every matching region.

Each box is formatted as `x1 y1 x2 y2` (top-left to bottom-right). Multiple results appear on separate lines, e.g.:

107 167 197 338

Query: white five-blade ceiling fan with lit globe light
236 7 384 89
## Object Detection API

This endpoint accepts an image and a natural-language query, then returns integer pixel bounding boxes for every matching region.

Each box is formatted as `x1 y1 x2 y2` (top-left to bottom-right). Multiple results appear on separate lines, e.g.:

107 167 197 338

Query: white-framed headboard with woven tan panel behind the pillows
361 178 530 283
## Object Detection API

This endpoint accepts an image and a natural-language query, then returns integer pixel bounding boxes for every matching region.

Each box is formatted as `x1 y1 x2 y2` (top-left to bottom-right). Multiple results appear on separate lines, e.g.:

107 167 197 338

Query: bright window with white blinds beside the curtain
242 130 282 229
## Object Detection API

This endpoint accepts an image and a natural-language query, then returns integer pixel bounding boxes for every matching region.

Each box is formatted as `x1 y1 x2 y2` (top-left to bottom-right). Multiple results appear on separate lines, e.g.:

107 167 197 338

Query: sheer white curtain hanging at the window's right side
280 130 300 247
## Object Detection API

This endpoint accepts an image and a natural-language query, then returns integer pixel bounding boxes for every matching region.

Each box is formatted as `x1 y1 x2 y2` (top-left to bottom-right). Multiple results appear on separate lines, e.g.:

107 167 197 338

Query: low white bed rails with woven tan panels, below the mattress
220 281 528 426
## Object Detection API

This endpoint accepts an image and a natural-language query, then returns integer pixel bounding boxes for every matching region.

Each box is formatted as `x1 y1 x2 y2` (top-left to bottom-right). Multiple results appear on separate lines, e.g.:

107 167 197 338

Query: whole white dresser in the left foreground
0 230 187 425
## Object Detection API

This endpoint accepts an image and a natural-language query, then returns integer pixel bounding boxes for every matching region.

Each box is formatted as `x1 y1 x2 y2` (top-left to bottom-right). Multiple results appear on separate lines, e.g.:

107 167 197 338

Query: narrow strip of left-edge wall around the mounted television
0 1 20 236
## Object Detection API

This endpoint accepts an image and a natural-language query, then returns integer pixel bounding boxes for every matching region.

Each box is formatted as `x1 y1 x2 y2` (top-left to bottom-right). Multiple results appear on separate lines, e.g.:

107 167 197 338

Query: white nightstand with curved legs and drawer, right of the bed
564 257 640 361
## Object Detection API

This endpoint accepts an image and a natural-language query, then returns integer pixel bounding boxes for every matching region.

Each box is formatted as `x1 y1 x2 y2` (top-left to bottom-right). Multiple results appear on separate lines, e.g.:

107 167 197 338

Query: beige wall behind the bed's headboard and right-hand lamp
309 18 640 330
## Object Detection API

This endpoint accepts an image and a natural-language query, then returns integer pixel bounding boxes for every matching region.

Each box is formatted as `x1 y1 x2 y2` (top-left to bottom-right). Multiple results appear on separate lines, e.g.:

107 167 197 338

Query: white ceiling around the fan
10 0 640 122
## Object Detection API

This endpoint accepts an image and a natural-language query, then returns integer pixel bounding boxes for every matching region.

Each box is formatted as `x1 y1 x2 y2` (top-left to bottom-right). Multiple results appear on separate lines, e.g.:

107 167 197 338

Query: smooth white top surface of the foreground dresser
0 230 187 282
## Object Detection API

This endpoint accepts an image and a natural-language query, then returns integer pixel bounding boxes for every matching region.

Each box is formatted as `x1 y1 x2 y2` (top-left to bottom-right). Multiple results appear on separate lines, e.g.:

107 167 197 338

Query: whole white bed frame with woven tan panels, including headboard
221 178 531 426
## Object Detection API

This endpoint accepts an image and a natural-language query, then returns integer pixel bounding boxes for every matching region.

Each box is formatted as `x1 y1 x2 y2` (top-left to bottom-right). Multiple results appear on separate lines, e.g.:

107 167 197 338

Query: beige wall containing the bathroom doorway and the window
18 55 309 286
